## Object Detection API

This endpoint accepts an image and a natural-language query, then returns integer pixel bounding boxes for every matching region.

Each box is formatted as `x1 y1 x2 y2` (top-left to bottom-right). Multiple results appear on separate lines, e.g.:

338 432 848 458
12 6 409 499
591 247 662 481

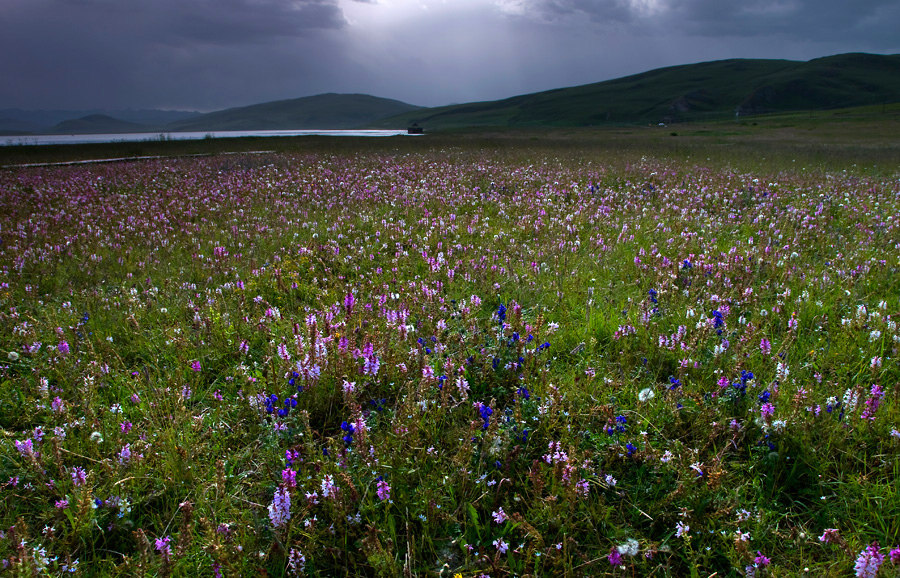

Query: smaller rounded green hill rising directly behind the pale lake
167 93 419 131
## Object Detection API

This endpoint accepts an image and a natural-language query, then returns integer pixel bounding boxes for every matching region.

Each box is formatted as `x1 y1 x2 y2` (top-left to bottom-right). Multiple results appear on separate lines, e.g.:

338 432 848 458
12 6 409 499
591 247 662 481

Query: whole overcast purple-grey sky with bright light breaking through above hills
0 0 900 111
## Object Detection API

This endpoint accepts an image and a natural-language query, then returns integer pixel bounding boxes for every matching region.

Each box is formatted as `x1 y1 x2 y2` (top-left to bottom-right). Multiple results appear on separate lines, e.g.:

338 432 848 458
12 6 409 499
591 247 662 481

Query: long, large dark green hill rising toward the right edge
373 53 900 130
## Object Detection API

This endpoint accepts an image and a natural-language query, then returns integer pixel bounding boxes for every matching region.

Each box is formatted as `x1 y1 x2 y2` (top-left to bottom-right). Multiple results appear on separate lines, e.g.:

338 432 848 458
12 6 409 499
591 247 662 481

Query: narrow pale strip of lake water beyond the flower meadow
0 129 414 146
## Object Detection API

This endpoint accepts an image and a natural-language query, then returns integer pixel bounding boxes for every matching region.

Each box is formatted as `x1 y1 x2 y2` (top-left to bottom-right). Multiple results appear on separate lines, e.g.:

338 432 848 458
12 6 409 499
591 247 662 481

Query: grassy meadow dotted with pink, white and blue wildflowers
0 120 900 578
